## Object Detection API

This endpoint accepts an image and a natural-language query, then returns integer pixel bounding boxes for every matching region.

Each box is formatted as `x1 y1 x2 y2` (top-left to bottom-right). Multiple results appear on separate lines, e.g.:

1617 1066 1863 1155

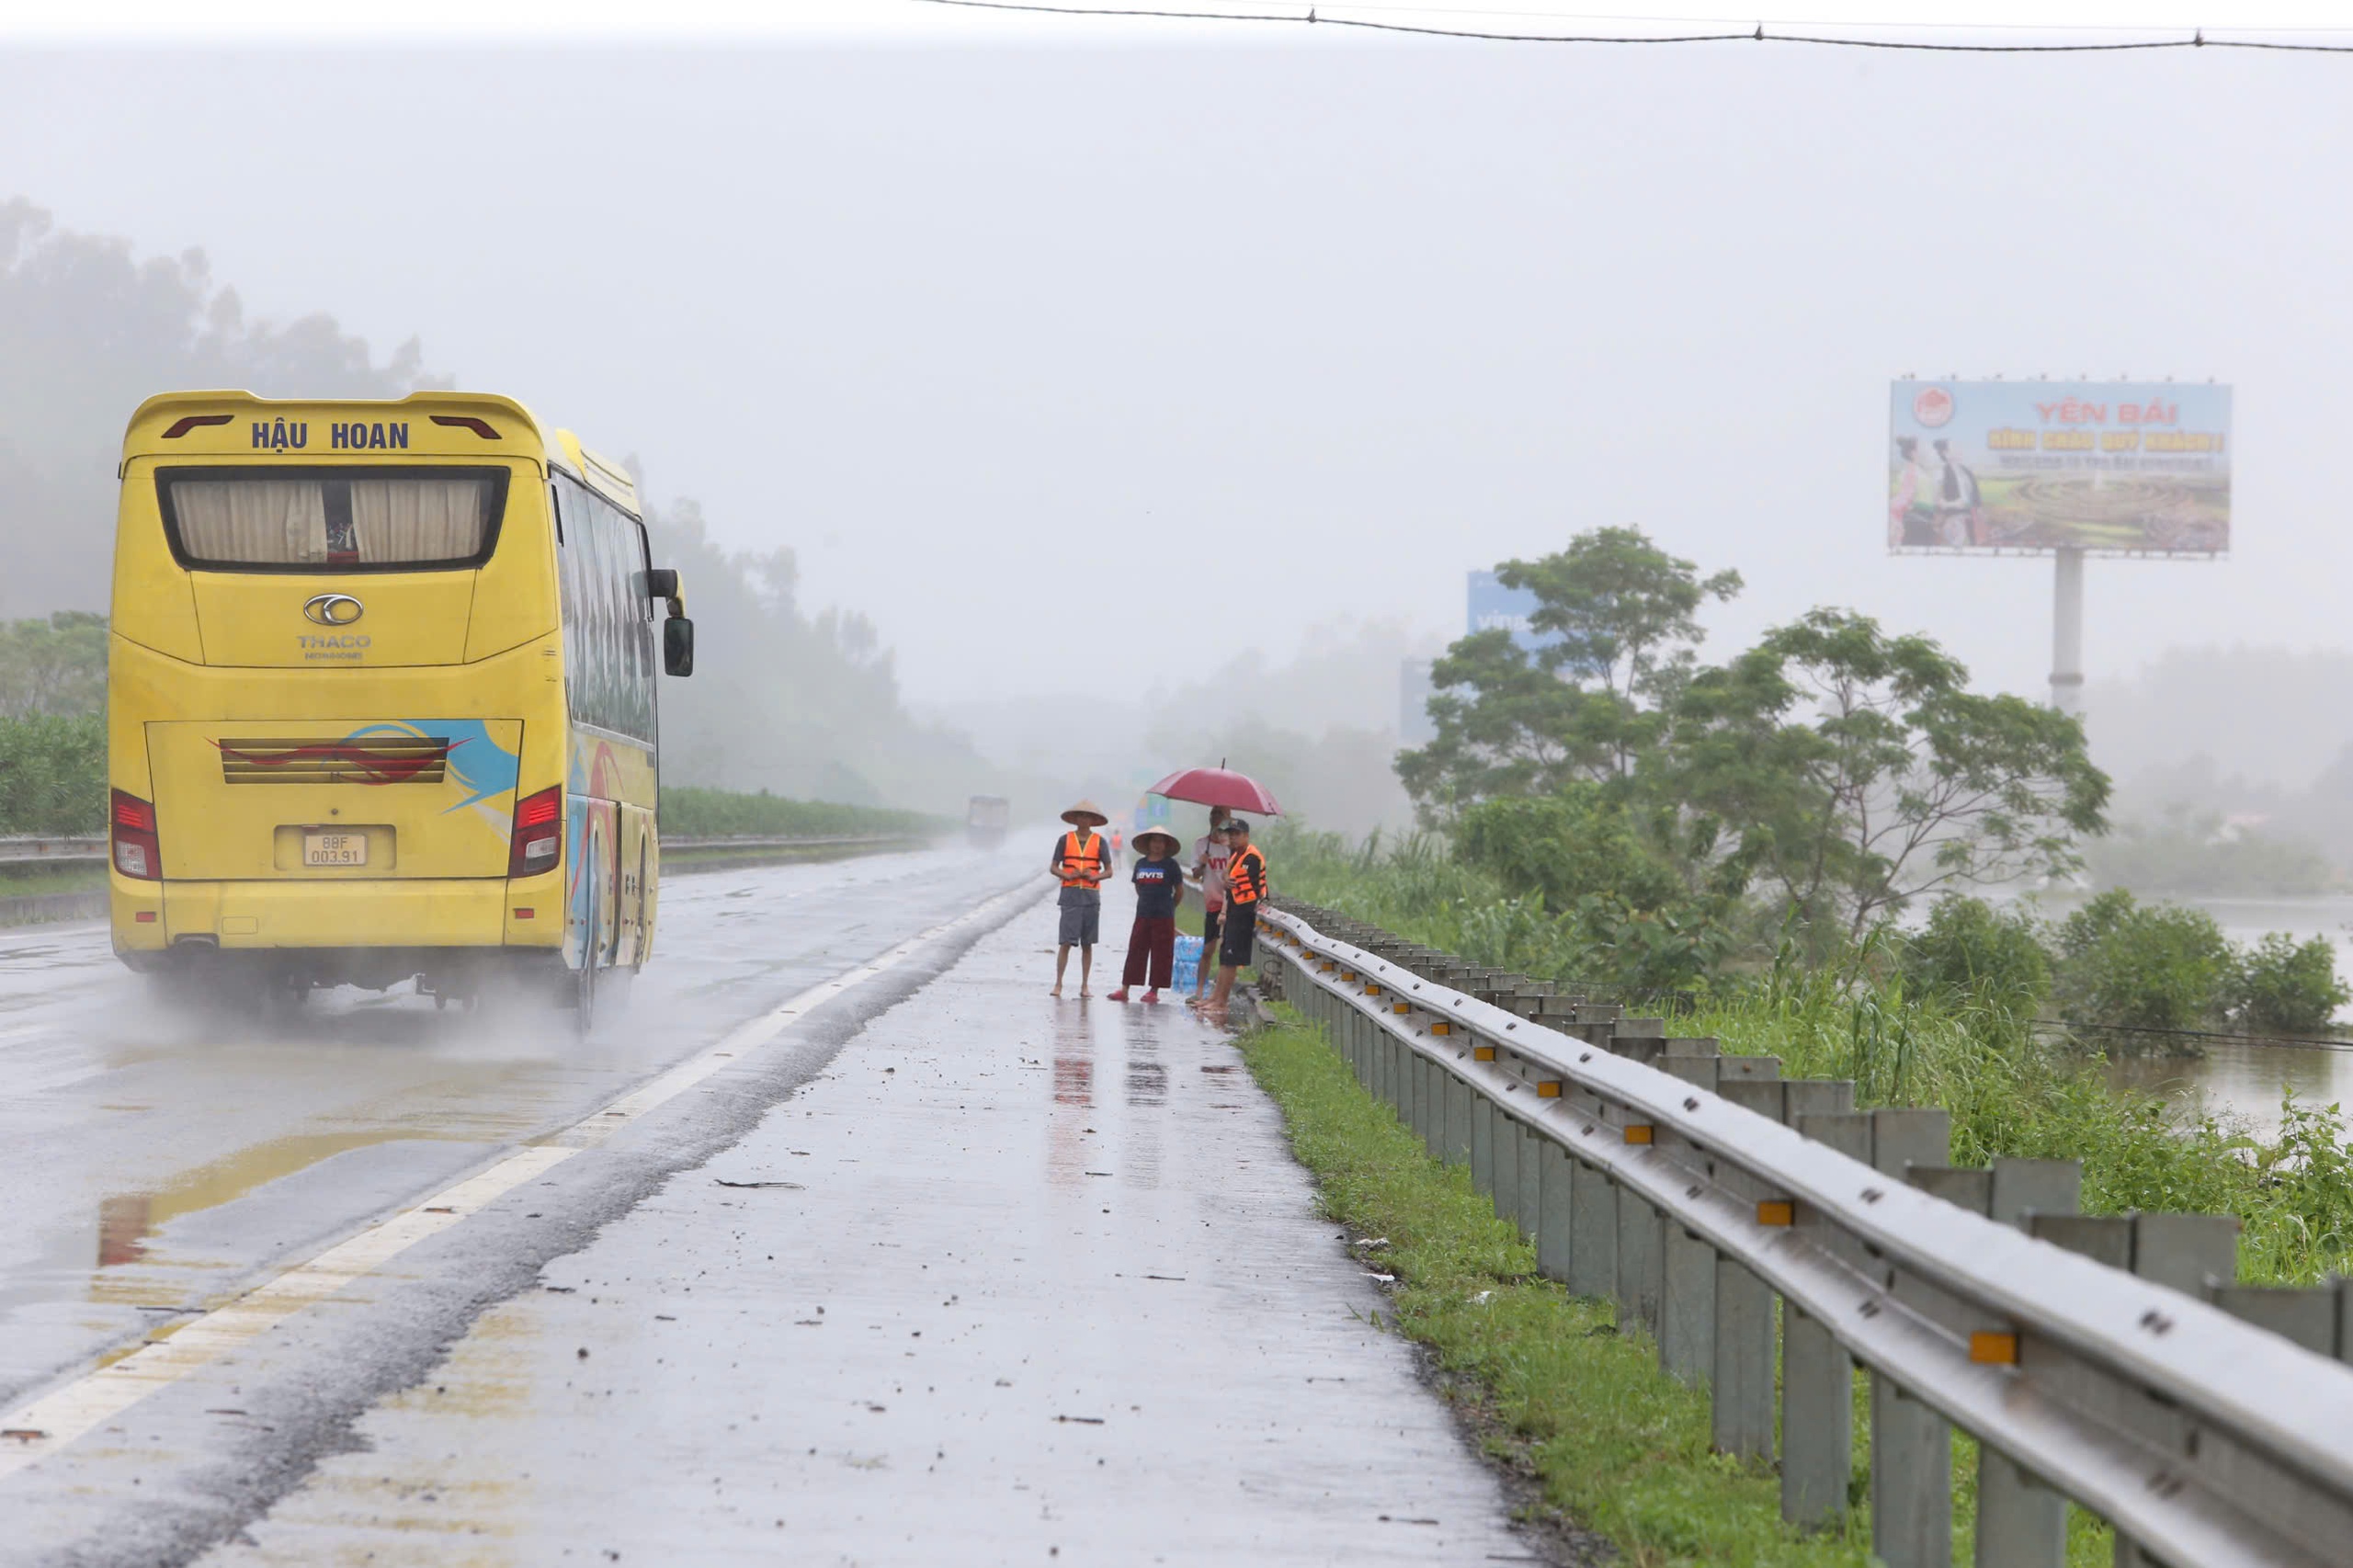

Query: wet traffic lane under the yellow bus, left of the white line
0 847 1018 1396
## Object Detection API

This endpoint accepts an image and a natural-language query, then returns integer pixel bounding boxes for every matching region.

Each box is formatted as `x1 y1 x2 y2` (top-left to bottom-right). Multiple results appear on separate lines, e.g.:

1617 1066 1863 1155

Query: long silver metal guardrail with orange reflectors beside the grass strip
1259 911 2353 1568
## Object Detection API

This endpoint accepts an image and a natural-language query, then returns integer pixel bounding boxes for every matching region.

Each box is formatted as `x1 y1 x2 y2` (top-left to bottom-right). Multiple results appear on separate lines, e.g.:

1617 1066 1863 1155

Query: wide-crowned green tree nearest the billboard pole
1665 609 2109 939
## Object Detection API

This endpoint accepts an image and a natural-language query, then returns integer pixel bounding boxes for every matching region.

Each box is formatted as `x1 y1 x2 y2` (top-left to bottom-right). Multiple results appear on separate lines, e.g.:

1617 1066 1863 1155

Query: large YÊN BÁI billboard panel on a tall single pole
1887 381 2231 556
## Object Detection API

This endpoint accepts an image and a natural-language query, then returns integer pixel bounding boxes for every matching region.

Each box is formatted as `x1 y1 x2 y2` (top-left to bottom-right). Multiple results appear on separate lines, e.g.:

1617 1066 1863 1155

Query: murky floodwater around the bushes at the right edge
2038 892 2353 1132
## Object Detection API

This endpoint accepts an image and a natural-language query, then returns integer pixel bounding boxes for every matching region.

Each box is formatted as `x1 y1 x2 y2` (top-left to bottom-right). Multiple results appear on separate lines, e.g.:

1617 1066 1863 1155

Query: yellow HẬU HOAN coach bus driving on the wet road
106 391 694 1028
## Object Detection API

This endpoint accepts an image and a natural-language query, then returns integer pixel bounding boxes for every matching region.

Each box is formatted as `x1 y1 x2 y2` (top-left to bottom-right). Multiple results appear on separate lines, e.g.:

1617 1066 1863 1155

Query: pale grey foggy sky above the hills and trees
0 38 2353 722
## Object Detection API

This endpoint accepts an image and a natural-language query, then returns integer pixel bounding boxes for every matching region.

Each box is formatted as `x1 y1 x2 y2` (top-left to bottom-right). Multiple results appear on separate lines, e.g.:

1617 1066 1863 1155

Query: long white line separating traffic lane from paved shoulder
0 888 1040 1481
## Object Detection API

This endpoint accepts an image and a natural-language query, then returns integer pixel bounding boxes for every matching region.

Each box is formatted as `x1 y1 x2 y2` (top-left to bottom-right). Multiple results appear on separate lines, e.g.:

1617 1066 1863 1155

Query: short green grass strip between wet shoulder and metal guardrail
1243 1007 2113 1568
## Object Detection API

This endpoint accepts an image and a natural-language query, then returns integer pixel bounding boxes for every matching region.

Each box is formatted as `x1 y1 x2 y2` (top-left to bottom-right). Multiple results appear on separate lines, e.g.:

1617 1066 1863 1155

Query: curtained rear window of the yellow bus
155 469 506 572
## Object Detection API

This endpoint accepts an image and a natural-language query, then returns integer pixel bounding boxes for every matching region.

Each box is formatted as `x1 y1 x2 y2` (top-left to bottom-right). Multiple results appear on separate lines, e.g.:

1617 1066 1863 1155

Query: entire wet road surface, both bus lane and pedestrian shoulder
0 852 1532 1568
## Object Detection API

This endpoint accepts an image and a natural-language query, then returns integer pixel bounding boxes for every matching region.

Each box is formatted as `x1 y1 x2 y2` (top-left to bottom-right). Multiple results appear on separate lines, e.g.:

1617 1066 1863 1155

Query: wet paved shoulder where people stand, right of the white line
202 904 1532 1568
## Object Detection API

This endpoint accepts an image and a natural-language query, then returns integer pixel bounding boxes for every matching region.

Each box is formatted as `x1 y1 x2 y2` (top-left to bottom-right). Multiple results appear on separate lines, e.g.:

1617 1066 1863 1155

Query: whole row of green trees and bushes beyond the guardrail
1395 528 2348 1031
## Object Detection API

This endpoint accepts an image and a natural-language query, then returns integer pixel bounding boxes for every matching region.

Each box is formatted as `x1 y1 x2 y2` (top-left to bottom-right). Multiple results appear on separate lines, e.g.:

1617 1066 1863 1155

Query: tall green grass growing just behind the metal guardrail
1268 831 2353 1283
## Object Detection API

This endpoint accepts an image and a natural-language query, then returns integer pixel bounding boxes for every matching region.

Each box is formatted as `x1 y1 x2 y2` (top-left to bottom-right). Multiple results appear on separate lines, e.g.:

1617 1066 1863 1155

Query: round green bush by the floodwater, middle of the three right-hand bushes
2054 890 2238 1048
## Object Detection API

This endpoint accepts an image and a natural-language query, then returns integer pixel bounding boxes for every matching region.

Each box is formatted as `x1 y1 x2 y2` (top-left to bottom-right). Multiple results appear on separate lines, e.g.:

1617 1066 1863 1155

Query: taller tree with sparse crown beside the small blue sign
1398 528 1741 822
